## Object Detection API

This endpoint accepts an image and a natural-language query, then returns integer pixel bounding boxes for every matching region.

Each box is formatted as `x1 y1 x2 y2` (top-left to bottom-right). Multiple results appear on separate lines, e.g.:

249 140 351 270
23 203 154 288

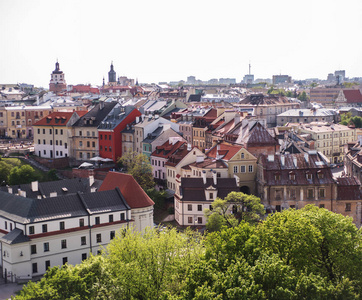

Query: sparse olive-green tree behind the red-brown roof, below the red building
117 152 155 190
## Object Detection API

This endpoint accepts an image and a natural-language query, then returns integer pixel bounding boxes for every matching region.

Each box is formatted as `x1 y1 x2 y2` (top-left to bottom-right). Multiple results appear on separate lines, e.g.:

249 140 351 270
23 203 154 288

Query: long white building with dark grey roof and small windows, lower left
0 189 130 282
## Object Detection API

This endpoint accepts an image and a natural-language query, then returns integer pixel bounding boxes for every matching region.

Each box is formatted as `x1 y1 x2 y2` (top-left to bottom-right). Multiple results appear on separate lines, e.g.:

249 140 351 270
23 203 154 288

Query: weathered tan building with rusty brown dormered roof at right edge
257 151 361 227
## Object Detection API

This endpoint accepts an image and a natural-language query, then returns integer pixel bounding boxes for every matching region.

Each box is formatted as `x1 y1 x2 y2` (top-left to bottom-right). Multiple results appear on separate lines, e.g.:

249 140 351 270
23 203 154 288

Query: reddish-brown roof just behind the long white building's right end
99 172 155 208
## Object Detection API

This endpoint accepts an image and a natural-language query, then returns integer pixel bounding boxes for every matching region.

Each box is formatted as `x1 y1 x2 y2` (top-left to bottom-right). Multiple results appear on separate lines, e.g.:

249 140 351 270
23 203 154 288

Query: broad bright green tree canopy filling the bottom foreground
16 205 362 300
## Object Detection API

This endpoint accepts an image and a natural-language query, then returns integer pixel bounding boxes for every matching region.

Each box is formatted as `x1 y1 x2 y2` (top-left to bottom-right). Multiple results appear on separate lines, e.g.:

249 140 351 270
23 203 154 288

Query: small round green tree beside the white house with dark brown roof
205 192 265 231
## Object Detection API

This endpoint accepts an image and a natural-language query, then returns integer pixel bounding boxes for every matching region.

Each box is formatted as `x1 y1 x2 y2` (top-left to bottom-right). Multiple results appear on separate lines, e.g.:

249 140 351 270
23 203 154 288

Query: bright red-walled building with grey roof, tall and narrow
98 105 141 162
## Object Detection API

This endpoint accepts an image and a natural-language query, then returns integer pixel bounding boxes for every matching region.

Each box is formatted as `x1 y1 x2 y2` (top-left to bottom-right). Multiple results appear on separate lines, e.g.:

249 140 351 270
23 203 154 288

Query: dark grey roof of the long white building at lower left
0 188 130 224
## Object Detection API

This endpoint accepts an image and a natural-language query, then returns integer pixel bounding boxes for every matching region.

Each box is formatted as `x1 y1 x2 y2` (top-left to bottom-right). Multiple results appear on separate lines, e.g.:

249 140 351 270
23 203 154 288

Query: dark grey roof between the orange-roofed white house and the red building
73 101 118 127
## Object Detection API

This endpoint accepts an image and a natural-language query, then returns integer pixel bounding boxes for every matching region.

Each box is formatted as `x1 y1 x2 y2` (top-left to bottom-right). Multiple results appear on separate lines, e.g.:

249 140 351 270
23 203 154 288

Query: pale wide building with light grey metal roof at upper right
277 108 339 126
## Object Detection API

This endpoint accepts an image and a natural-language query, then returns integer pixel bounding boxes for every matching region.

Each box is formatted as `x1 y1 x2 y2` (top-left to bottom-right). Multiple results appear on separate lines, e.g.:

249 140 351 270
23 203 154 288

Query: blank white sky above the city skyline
0 0 362 88
